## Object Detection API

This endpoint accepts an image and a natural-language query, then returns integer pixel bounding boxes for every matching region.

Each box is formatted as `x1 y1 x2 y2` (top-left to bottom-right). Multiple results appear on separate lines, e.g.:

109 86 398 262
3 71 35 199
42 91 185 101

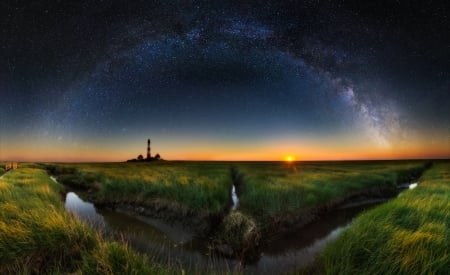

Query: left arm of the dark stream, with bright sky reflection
65 192 237 273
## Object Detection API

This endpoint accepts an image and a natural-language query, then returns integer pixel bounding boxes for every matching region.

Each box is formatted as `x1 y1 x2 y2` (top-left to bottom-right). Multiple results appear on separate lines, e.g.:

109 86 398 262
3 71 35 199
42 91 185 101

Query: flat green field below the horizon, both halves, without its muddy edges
46 161 425 222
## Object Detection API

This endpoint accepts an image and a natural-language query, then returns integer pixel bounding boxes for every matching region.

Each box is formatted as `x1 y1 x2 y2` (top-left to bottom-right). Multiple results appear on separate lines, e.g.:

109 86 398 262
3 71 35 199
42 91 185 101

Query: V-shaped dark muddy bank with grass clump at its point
93 179 416 264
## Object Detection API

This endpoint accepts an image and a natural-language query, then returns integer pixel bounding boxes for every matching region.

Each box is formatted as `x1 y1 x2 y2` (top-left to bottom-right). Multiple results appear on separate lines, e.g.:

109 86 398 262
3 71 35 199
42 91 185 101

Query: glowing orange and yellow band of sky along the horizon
0 133 450 162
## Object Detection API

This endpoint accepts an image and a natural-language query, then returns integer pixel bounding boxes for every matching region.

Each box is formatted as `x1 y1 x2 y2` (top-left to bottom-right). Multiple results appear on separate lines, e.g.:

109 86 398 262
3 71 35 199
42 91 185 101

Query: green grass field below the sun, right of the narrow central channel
237 161 425 223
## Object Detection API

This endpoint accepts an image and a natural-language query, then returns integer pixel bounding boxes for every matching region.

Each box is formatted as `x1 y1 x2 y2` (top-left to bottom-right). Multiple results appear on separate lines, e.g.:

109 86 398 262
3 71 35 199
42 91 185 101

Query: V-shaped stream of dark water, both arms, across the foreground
65 183 417 274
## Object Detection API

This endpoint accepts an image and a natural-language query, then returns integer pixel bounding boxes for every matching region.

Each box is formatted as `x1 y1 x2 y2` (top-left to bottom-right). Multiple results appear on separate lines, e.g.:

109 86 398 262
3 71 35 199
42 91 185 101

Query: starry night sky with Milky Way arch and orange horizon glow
0 0 450 161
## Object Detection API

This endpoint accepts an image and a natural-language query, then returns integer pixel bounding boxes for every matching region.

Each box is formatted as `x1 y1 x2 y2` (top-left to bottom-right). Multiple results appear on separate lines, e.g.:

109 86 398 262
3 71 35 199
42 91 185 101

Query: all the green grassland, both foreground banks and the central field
0 161 444 274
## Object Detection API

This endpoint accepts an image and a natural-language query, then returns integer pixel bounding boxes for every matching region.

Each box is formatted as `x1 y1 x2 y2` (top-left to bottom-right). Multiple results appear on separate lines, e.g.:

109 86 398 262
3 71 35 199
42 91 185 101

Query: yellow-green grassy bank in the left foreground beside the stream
0 168 170 274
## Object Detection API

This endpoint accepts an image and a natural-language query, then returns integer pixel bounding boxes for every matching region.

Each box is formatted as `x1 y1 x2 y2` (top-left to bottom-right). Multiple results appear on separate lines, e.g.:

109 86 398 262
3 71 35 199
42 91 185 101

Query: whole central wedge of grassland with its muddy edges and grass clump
47 161 425 258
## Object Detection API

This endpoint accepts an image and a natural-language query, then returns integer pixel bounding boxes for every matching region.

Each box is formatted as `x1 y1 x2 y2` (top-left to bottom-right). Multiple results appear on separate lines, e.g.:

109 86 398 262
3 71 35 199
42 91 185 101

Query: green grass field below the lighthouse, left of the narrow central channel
48 162 232 216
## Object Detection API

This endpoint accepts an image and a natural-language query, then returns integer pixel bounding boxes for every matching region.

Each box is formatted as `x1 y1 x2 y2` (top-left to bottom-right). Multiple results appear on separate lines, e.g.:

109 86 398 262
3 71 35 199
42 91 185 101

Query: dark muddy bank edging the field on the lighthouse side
46 165 233 237
